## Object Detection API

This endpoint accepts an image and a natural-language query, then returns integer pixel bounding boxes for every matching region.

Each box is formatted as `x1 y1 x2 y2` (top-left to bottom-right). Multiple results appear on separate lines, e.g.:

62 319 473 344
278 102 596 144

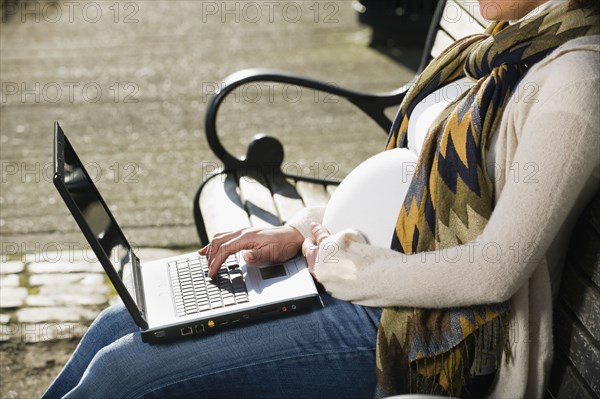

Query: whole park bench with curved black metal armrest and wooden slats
193 0 600 398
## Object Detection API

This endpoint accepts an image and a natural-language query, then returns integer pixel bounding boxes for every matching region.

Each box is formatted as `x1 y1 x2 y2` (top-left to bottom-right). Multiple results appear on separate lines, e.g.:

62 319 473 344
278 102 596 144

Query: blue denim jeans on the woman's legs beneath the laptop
43 294 381 399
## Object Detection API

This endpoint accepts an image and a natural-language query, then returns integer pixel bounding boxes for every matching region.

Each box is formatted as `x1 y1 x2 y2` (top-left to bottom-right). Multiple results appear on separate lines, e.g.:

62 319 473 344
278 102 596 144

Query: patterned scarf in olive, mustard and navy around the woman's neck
376 1 599 397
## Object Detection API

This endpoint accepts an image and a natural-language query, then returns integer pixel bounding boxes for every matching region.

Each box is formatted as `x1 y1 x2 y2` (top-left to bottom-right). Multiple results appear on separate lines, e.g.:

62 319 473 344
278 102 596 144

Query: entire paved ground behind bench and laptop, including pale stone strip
0 0 419 398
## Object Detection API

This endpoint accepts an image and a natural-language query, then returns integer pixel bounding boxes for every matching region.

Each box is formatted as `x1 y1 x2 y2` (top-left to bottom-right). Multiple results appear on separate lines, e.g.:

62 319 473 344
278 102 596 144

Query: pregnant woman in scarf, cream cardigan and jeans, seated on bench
45 0 600 398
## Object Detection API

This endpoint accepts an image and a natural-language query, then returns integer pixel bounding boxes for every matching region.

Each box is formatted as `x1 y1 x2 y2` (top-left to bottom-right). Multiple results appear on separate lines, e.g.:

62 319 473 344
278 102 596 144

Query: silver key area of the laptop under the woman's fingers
168 256 248 316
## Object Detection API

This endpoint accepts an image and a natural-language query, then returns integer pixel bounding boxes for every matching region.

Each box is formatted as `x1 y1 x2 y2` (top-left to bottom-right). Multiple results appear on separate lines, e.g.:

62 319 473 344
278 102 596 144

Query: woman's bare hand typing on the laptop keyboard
198 226 304 278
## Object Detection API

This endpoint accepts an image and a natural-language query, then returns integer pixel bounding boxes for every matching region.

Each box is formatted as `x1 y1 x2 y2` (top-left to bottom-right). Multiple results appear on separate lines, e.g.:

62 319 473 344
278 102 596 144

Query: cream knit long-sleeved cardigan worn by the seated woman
288 36 600 398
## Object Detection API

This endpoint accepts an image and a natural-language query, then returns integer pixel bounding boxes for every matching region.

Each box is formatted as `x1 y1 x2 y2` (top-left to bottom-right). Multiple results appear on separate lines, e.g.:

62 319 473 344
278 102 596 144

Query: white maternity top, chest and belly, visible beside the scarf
323 78 497 248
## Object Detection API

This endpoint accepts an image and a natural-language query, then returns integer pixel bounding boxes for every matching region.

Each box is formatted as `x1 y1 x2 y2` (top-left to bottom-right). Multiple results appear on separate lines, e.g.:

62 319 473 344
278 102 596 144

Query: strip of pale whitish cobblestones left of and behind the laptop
0 248 180 343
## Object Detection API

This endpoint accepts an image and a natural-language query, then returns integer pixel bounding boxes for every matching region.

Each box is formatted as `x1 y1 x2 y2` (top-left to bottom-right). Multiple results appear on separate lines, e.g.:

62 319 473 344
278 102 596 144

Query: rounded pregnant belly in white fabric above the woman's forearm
323 148 417 248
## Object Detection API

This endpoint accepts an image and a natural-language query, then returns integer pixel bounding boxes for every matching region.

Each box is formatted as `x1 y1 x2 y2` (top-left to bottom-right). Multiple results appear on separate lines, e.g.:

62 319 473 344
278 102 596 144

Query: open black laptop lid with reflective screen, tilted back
54 122 147 328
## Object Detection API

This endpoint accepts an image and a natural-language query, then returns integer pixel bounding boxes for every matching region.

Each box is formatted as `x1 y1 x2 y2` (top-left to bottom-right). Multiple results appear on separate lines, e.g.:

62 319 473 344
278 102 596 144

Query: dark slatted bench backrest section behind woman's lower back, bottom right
548 193 600 398
